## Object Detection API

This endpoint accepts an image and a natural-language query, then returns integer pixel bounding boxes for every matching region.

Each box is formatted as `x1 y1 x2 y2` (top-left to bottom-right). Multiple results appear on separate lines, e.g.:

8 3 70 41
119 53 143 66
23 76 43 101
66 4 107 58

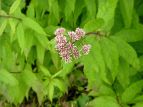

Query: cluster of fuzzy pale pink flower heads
55 28 91 63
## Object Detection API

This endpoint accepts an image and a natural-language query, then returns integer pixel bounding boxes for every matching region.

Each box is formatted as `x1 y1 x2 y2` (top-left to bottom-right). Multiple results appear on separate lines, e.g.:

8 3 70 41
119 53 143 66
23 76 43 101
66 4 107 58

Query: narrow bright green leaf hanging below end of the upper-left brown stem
17 23 26 52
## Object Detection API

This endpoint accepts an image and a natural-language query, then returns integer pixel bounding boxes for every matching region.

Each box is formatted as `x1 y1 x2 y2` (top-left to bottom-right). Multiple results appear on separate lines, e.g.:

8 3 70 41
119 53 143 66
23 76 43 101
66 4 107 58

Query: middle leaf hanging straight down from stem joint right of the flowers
100 38 119 81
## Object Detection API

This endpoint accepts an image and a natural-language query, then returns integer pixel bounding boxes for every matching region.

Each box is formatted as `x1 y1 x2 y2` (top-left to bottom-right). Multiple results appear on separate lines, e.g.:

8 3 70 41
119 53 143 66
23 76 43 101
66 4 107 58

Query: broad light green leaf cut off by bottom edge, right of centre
87 96 120 107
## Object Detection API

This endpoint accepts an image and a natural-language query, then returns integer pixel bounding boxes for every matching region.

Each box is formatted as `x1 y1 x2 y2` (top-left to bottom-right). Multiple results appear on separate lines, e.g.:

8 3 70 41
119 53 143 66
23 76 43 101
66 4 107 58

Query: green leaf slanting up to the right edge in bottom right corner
122 80 143 103
